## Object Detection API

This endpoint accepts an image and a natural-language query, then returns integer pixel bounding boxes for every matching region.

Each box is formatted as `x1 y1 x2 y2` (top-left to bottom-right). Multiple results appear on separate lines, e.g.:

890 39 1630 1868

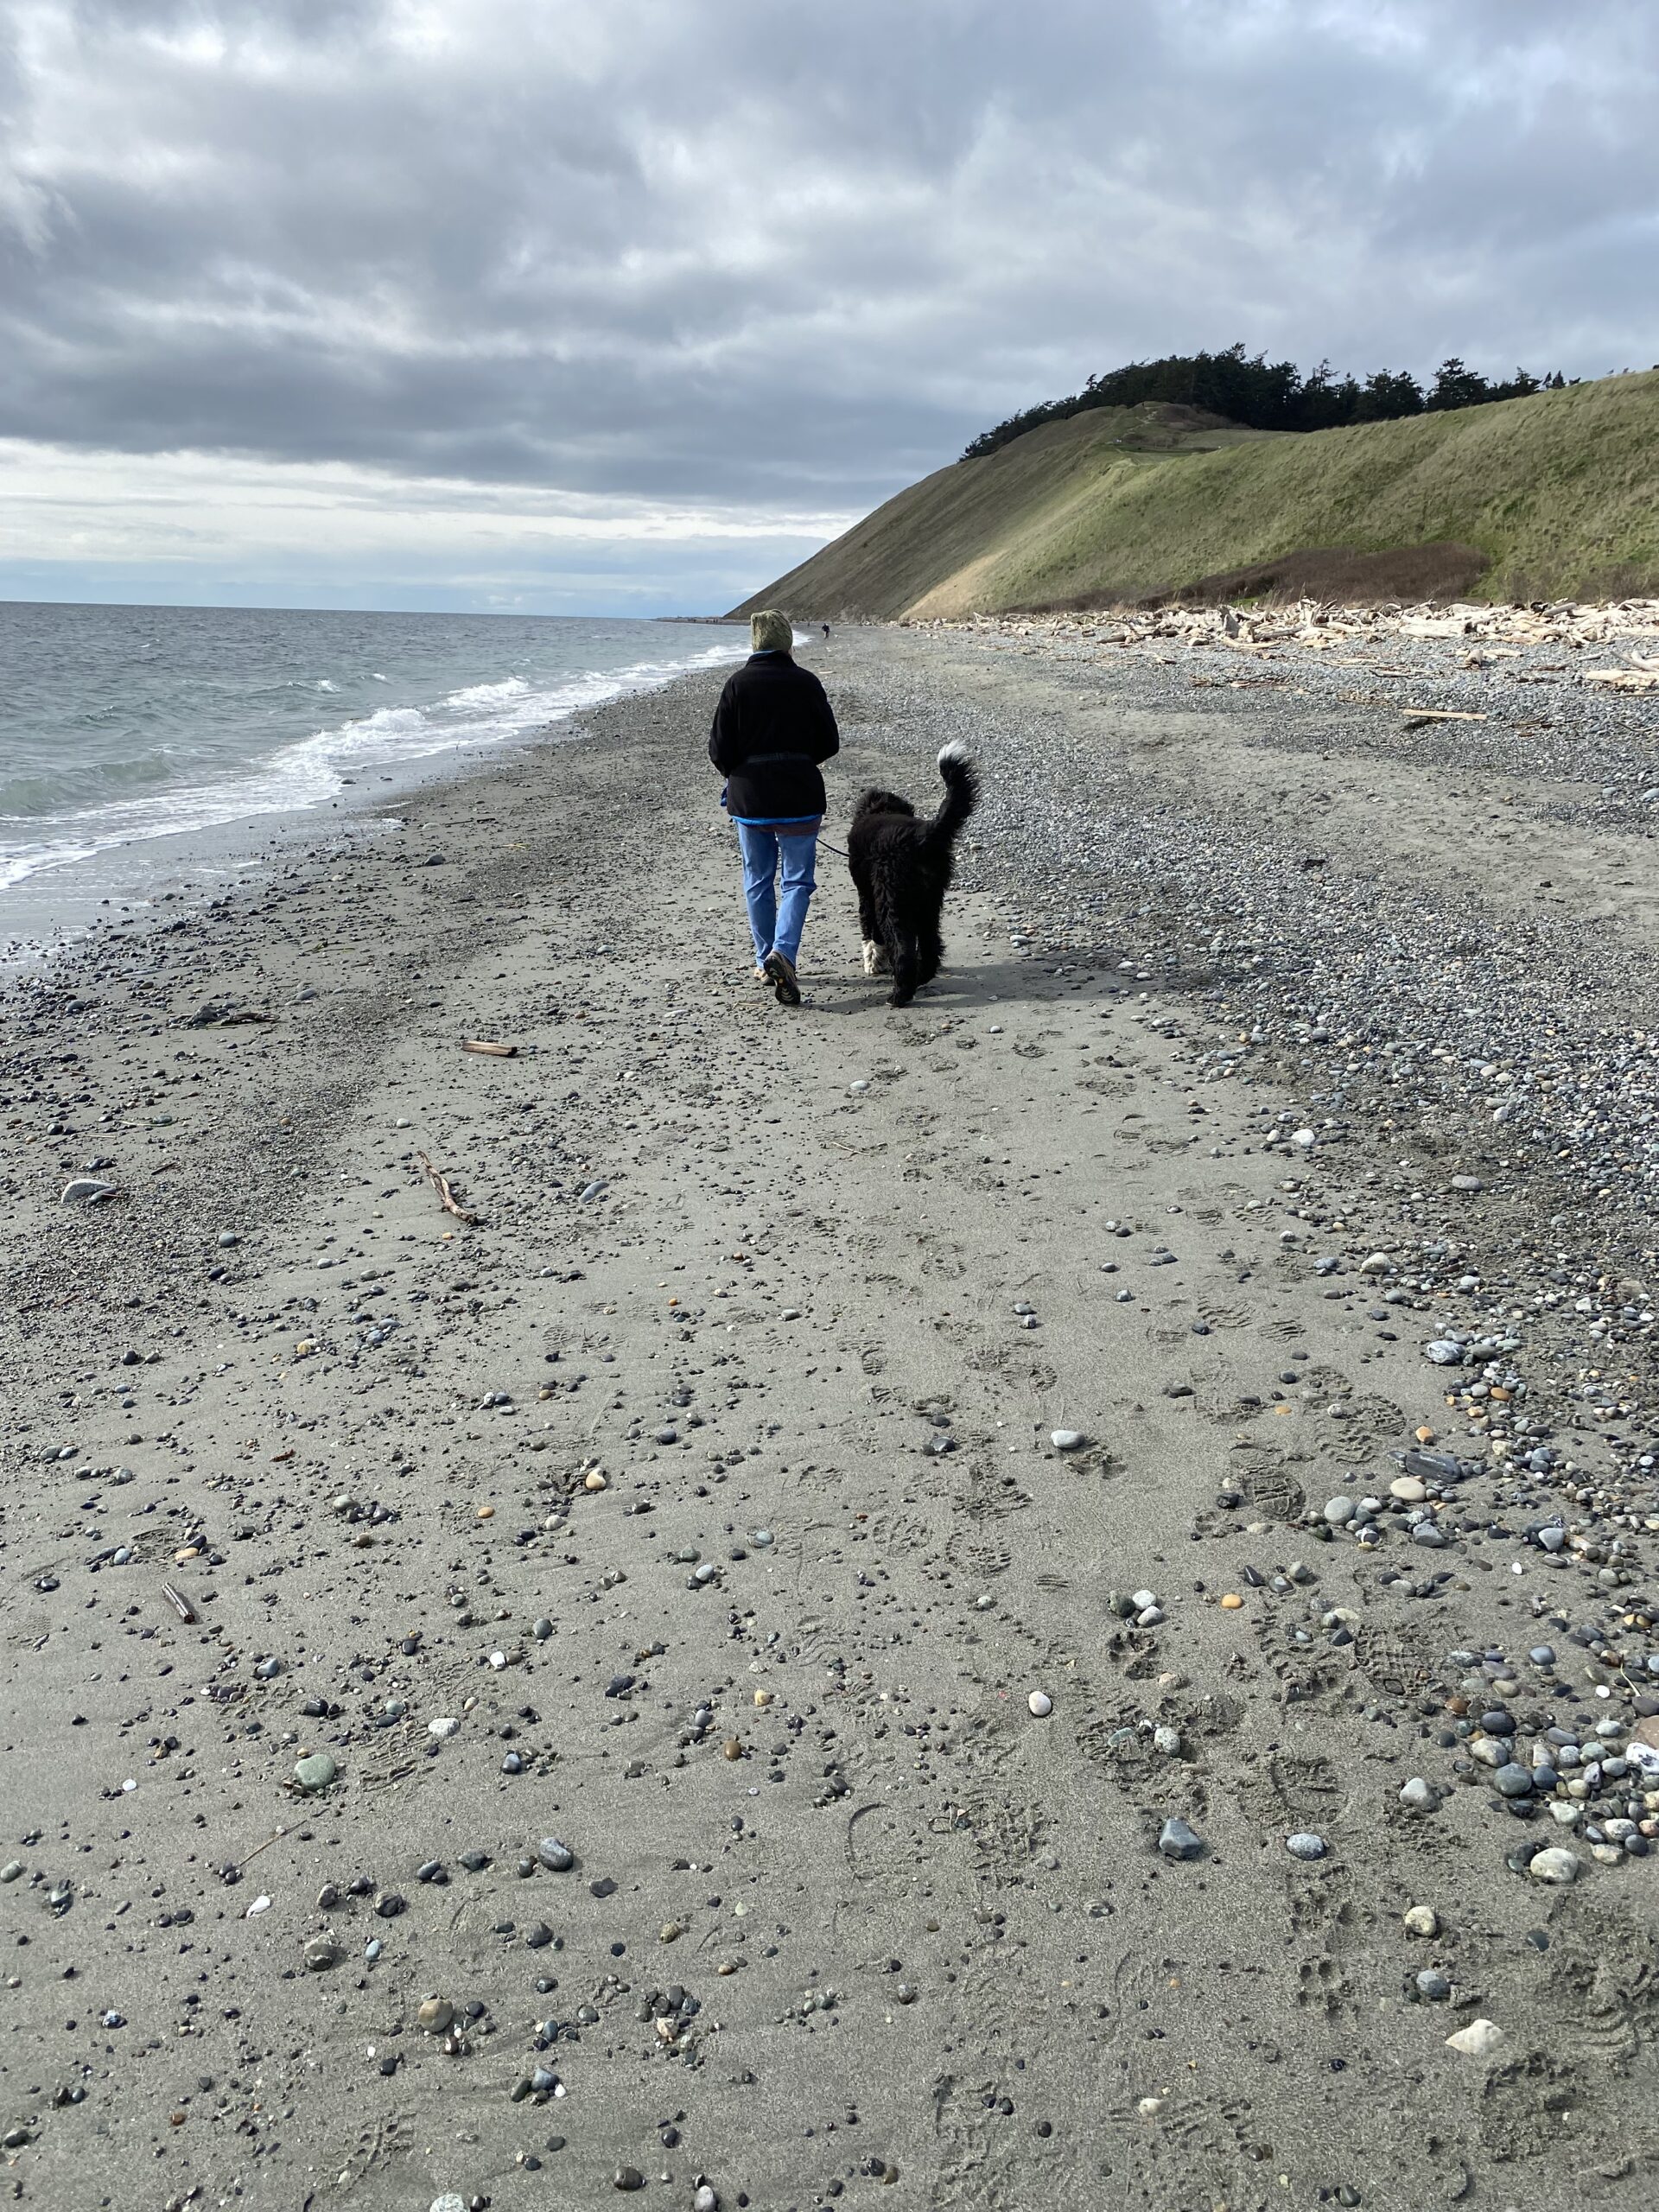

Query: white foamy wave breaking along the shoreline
0 644 743 892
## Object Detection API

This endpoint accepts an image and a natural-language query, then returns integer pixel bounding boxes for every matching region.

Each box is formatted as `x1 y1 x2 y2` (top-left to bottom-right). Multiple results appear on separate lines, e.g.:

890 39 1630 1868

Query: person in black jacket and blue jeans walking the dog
708 608 841 1007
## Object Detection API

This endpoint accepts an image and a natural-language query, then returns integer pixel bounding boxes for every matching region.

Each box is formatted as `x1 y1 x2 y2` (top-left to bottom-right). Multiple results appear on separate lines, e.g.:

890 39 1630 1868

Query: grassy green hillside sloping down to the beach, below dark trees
734 372 1659 621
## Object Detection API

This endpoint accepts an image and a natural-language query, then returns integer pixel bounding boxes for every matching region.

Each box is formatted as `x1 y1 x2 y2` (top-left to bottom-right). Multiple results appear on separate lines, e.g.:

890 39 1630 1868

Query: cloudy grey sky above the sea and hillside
0 0 1659 615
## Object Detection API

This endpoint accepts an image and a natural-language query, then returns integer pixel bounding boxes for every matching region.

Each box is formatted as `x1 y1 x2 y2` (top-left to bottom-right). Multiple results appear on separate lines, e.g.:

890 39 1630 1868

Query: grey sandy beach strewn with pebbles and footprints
0 631 1659 2212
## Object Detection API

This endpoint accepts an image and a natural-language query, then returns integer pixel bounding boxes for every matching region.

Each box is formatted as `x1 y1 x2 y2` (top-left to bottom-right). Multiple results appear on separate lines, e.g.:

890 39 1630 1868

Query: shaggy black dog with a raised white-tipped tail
847 746 980 1007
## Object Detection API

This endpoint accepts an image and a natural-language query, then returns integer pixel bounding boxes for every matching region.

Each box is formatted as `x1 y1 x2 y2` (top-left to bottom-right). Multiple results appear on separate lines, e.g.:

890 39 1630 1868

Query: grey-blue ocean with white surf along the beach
0 601 747 960
